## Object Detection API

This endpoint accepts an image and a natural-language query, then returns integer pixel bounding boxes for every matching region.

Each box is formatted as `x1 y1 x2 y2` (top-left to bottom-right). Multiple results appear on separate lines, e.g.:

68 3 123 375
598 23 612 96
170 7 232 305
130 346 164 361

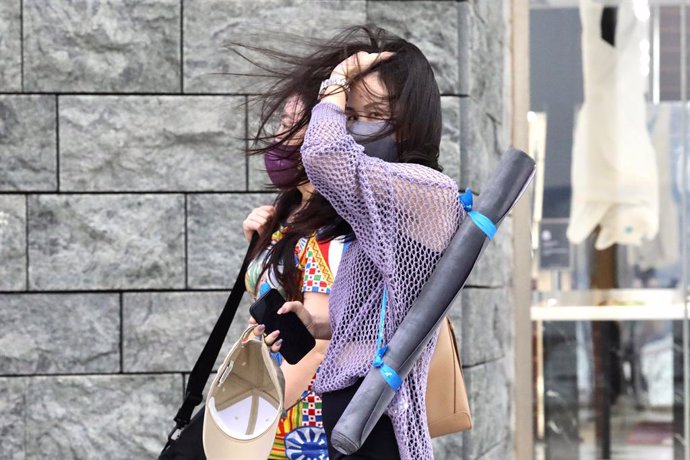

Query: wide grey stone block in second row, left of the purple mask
58 96 246 192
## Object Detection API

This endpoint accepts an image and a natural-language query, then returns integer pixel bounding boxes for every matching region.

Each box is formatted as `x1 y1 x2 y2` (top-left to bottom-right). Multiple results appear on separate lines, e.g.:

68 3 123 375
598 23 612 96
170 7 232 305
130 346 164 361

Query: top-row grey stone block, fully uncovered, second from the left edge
22 0 182 93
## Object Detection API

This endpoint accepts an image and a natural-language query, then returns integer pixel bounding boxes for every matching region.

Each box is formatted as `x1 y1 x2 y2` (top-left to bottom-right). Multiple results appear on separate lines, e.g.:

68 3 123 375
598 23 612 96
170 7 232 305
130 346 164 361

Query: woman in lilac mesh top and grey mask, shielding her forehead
250 27 464 460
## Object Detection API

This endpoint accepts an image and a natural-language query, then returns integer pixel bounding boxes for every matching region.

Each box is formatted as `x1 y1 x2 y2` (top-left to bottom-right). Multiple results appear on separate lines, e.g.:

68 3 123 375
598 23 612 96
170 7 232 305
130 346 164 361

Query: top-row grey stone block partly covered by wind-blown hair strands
183 0 367 93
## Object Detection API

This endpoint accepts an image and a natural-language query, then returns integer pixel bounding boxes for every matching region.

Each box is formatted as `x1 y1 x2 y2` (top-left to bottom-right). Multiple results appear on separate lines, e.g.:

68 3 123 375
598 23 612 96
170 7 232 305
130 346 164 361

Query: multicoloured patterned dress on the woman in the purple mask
245 226 348 460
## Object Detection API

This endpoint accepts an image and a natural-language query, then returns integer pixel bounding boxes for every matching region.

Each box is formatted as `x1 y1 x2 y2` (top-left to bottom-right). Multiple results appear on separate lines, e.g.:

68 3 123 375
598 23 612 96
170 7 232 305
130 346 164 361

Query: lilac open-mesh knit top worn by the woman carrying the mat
301 102 465 460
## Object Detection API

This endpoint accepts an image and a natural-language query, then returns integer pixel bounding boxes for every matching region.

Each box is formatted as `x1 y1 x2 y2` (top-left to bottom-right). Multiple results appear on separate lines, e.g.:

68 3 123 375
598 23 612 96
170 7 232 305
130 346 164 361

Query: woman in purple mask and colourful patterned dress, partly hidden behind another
242 97 351 459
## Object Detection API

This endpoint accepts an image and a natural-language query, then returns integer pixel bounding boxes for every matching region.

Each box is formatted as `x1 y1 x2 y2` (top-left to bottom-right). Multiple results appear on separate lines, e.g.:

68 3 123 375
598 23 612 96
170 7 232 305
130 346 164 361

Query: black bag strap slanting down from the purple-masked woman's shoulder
163 232 259 450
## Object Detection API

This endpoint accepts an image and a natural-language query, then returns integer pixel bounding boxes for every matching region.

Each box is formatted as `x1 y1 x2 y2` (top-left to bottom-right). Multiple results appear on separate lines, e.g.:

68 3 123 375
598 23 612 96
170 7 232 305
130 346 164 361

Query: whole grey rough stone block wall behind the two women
0 0 513 460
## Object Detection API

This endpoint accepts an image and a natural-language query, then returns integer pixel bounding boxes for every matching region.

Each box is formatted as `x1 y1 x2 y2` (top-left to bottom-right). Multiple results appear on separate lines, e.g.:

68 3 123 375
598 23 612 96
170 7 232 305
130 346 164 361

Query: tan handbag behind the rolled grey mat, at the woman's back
426 317 472 438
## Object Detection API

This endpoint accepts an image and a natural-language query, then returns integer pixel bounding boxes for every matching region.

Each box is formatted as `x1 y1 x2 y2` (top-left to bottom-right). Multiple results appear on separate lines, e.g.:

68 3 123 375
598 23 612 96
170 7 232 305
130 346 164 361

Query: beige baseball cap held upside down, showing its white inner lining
203 327 285 460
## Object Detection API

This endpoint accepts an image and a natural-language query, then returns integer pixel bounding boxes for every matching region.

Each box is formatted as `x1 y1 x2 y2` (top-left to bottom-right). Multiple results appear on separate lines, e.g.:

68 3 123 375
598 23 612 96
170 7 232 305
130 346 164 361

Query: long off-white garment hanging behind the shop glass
568 0 659 249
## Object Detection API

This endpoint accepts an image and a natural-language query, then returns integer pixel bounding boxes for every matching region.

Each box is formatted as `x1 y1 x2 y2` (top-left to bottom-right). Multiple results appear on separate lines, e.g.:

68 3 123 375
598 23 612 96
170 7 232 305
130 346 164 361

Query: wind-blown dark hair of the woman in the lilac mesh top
243 26 442 174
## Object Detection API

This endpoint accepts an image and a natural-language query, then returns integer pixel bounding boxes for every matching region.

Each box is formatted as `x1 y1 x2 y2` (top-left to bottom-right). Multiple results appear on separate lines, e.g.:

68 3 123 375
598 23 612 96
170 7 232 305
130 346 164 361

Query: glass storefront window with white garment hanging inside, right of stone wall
527 0 690 460
